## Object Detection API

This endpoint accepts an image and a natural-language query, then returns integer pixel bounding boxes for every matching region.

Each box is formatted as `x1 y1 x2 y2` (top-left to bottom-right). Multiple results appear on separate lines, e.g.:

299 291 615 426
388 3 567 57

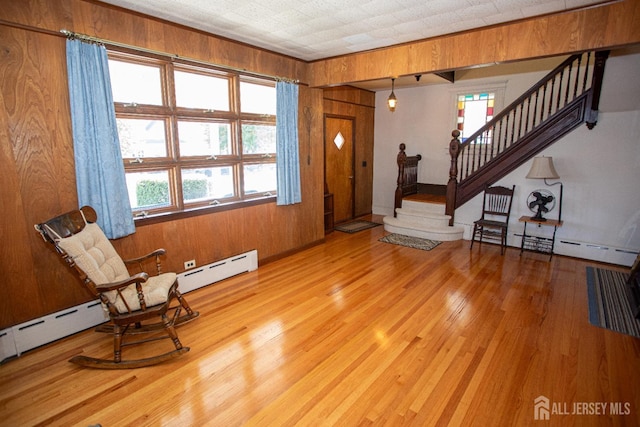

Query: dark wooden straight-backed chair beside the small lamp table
469 185 516 255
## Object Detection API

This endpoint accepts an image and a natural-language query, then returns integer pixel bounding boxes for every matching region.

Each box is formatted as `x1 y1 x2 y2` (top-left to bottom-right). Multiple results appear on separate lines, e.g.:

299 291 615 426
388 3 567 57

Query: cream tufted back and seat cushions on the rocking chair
58 223 176 313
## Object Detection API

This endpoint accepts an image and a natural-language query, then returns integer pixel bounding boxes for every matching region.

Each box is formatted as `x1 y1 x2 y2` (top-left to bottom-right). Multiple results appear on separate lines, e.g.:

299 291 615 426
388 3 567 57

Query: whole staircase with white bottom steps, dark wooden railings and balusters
383 51 609 241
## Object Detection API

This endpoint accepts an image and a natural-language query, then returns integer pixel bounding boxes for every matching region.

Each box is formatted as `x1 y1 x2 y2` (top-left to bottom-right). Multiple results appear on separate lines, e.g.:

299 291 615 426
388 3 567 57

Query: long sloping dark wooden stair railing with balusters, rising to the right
446 51 609 225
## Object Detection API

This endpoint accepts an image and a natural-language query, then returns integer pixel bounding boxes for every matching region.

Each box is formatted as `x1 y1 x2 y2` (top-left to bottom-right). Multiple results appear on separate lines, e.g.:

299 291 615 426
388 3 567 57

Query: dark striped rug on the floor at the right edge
587 267 640 338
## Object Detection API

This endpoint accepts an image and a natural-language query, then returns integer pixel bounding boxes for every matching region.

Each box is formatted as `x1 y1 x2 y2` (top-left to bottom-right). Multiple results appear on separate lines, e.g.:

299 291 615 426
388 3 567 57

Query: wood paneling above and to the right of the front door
324 86 376 217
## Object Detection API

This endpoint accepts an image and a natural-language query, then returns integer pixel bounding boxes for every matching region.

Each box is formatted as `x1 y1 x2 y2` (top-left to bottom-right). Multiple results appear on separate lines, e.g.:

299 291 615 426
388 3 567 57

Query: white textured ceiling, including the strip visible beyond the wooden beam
102 0 610 90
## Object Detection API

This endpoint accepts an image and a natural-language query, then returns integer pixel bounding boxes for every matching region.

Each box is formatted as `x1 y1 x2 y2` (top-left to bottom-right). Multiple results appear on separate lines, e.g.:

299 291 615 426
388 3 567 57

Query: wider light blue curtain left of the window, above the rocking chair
67 39 135 239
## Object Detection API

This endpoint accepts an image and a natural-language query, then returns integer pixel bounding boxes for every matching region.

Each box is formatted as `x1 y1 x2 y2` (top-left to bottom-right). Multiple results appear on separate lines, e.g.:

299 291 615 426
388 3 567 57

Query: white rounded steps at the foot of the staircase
383 199 464 242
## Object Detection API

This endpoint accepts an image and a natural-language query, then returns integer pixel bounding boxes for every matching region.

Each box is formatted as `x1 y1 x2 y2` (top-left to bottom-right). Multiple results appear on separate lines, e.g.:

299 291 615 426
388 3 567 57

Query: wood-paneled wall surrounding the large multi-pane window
0 0 324 329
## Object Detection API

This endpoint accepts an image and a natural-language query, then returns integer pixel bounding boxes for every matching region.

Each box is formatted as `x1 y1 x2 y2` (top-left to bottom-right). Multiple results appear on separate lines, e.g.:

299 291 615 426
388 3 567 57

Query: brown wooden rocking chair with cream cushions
35 206 199 369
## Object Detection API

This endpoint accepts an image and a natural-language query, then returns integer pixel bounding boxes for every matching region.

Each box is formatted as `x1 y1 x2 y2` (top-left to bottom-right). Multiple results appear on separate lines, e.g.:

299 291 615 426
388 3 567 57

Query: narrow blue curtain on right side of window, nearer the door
276 81 302 205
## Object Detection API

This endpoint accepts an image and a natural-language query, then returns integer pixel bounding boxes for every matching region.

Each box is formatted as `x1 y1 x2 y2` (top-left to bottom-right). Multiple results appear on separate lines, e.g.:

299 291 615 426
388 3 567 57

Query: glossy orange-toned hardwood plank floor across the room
0 222 640 427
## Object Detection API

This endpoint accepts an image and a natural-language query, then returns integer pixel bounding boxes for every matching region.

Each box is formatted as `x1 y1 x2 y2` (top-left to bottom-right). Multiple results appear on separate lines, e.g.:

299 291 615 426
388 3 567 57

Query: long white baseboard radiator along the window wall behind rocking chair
0 250 258 363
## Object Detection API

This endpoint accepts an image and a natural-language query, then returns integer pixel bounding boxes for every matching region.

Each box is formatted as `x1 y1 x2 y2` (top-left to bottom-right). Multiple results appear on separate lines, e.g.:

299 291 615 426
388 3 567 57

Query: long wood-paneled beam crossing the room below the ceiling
309 0 640 87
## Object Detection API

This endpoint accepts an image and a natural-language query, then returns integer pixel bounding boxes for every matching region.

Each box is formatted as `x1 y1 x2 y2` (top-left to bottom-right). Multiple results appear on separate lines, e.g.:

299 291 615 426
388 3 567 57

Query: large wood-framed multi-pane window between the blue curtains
109 51 276 216
